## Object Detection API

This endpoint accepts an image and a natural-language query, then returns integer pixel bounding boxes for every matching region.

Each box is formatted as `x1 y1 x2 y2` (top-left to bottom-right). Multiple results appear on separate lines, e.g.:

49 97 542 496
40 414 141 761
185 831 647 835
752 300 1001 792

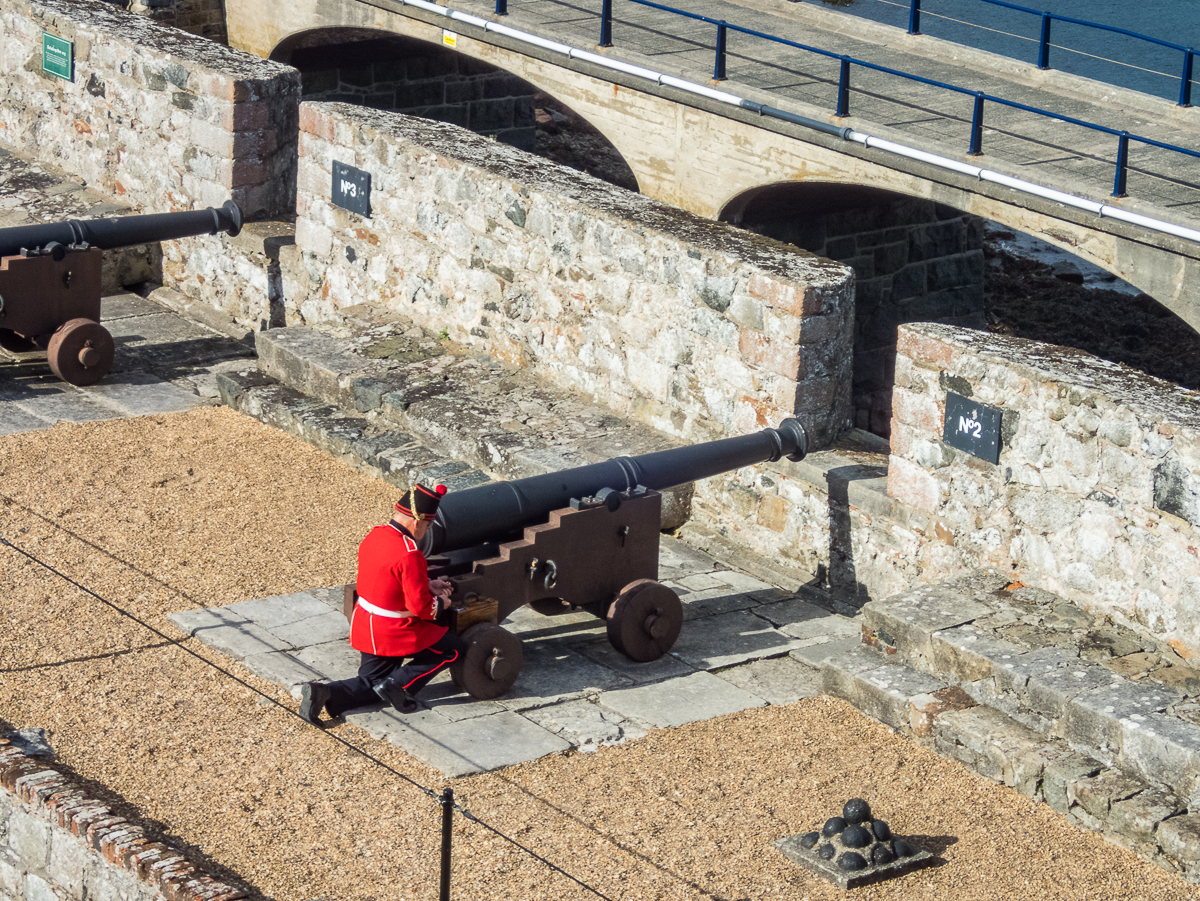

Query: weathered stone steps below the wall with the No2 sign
821 572 1200 882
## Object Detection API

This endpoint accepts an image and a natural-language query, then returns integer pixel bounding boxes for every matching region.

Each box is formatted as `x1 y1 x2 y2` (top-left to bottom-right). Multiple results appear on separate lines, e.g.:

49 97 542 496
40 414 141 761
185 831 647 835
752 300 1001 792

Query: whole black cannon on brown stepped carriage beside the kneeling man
346 419 808 698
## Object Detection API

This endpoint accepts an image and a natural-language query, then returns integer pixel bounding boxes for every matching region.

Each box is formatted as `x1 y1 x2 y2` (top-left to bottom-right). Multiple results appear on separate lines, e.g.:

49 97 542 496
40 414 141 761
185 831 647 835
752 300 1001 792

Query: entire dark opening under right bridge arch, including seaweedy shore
720 182 1200 437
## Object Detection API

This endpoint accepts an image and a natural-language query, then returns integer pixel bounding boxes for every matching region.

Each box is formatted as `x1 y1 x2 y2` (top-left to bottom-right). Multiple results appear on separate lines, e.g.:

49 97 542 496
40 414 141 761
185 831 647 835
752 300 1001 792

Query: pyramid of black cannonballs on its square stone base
775 798 932 889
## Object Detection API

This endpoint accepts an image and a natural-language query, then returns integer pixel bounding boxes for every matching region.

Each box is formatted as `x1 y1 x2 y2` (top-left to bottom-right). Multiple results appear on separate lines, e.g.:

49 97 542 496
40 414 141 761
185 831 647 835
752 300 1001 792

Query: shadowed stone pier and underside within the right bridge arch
720 182 984 437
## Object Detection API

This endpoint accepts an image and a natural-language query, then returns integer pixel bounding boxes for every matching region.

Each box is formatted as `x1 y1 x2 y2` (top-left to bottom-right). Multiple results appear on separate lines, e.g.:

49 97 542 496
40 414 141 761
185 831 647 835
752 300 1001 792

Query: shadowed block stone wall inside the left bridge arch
287 37 538 150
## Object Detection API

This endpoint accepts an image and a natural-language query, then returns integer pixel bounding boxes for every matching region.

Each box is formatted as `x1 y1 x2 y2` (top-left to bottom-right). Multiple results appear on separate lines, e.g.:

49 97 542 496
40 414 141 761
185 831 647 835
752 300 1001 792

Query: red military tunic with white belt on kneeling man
350 523 446 657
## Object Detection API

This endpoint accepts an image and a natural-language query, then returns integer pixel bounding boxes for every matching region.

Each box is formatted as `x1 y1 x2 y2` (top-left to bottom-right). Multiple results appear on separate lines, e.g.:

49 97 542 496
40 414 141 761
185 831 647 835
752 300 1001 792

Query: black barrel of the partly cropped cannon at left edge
0 200 241 257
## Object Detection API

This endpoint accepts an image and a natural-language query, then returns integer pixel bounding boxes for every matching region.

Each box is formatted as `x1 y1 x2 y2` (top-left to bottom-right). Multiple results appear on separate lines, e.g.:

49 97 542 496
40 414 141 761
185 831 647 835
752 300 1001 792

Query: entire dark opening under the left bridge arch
270 28 637 191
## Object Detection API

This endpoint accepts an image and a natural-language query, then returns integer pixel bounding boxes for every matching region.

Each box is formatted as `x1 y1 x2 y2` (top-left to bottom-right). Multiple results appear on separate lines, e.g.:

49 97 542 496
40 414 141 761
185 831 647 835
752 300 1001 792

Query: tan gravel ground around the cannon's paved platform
0 408 1200 901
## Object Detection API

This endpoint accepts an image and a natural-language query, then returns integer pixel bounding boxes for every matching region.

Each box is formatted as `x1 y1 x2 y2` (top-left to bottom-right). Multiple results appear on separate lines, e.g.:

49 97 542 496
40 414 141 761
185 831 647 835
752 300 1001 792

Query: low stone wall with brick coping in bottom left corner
0 739 248 901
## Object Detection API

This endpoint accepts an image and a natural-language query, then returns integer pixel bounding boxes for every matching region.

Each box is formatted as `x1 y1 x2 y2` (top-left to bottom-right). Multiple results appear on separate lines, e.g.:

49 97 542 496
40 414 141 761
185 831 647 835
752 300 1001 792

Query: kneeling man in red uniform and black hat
300 485 467 723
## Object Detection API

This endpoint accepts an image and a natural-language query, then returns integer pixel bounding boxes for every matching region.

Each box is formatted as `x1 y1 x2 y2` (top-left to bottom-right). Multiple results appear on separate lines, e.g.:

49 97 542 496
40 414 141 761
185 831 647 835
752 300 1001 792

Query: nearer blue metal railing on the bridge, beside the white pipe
566 0 1200 197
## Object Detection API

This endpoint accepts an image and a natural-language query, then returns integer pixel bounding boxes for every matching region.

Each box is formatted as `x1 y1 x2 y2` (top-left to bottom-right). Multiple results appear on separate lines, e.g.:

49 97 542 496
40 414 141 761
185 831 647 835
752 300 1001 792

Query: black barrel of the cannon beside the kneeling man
421 419 809 555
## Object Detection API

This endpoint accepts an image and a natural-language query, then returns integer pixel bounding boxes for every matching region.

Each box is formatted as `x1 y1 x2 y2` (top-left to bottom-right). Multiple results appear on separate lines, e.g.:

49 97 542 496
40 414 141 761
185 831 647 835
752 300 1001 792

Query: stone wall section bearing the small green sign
0 0 300 218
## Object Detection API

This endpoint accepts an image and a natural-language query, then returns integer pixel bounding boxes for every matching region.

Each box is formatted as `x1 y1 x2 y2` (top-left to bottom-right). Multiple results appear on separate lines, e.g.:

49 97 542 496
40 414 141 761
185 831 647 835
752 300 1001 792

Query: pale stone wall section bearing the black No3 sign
282 103 853 445
